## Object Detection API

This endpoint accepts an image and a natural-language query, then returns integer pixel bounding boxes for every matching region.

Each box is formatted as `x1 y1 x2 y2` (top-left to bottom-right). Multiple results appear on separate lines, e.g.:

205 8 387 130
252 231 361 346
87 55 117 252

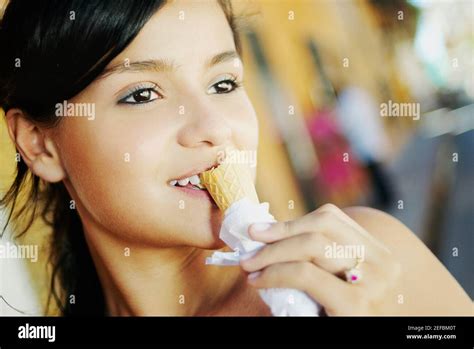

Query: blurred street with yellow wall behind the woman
0 0 474 314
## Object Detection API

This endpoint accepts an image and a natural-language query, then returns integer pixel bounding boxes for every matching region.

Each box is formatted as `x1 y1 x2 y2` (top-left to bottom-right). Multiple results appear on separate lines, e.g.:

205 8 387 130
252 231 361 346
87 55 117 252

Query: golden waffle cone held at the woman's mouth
199 162 259 212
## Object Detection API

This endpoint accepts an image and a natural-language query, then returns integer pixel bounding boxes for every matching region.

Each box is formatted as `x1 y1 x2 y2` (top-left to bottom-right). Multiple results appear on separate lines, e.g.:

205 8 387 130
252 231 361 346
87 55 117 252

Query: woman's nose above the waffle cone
178 100 232 148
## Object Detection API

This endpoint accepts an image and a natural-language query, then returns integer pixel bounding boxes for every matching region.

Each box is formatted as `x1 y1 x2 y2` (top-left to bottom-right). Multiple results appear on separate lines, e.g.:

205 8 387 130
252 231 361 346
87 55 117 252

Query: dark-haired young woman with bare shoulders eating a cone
0 0 472 315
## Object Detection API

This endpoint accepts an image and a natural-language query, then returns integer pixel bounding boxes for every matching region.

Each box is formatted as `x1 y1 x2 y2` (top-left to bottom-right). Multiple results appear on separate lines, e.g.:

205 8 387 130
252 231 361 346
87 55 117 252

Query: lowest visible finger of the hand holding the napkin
249 262 354 309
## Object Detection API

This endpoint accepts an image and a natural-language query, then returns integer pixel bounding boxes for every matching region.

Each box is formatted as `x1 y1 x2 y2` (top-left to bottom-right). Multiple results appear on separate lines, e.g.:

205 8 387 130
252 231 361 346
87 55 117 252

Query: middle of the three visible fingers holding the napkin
240 228 355 274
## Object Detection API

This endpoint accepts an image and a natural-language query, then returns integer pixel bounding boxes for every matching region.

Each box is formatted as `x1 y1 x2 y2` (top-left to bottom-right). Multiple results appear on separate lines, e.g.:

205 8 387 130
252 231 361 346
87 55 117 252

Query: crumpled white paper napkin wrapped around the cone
206 198 321 316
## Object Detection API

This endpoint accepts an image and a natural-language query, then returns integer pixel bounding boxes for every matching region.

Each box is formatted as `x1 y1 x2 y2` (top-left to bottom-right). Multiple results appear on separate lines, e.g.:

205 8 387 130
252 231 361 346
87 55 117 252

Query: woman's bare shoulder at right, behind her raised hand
343 207 473 315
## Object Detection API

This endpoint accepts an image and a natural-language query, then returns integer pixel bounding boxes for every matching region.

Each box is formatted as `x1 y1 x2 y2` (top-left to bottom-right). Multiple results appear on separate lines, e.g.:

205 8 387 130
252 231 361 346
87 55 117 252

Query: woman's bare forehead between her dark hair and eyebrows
109 0 235 67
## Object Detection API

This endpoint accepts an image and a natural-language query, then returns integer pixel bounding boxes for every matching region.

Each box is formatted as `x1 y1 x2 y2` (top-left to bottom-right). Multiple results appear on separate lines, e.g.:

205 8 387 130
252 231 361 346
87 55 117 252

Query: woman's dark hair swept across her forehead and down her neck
0 0 241 315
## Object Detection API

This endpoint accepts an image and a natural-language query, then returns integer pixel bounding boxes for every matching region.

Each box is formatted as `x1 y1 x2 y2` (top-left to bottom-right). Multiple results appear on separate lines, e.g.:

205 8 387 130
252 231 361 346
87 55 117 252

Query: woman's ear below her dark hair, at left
5 108 66 183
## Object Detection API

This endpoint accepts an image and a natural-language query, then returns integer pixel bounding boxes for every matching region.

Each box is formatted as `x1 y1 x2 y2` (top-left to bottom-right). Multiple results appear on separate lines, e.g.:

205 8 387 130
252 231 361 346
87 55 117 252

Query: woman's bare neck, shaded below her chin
84 225 245 316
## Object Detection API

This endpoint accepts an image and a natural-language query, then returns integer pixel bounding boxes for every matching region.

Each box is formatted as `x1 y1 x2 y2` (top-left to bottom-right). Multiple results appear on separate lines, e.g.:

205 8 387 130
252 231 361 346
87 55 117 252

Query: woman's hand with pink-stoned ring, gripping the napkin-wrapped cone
241 204 401 315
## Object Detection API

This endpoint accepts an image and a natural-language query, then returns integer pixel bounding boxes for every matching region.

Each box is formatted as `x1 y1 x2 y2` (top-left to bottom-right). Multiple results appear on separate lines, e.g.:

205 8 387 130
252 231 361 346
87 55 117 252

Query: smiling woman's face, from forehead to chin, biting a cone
53 1 258 248
